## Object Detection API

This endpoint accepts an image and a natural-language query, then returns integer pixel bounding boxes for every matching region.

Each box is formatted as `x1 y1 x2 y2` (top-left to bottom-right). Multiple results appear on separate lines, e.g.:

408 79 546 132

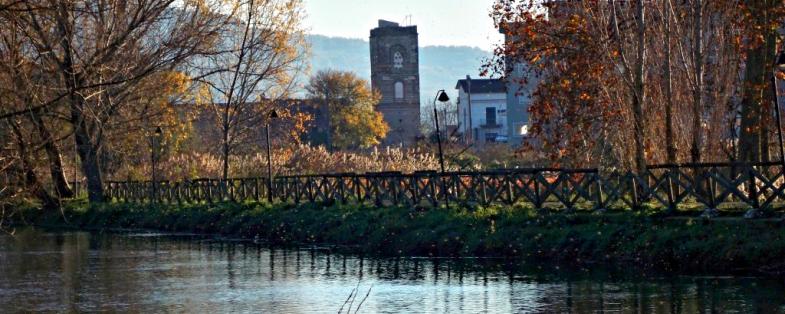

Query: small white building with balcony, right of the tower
455 75 510 145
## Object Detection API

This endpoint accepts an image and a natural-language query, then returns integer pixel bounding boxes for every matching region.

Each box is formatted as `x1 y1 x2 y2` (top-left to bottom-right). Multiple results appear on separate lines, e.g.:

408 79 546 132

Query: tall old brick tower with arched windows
370 20 420 146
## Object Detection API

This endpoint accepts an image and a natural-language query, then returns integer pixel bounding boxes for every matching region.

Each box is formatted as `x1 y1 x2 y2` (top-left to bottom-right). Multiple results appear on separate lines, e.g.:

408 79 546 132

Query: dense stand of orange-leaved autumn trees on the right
485 0 783 169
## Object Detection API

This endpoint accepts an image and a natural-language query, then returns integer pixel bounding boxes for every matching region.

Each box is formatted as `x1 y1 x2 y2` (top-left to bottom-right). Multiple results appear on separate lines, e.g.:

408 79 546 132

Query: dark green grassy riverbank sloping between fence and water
10 203 785 274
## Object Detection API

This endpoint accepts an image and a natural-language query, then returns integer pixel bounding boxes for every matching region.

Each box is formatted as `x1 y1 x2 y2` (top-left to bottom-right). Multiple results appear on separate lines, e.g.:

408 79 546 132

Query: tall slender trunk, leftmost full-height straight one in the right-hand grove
632 0 646 174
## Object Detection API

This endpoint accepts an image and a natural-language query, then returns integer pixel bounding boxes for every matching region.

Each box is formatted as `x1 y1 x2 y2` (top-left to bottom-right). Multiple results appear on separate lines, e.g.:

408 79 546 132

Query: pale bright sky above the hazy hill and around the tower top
305 0 501 50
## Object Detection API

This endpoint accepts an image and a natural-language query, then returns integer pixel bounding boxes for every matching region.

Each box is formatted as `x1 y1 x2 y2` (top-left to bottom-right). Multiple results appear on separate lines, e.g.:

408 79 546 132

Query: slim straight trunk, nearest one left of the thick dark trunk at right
690 0 703 163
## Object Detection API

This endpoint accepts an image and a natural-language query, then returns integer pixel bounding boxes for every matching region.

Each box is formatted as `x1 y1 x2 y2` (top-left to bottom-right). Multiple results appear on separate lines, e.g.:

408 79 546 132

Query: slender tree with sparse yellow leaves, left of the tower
194 0 306 179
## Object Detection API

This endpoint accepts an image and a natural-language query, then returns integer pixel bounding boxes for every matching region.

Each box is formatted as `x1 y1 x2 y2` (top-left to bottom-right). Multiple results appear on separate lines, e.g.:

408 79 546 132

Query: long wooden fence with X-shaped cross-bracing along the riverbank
106 163 785 210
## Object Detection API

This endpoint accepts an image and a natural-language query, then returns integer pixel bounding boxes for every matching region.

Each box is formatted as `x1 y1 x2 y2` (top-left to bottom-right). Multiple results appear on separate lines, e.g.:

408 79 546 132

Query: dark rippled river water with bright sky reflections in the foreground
0 230 785 313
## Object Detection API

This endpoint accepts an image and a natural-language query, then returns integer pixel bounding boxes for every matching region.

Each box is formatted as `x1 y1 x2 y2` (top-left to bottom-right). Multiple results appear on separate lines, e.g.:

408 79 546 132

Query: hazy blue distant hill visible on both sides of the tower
308 35 492 104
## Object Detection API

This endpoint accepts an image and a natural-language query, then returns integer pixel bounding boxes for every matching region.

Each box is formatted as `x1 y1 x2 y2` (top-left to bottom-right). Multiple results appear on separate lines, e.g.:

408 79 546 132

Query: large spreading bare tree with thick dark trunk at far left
4 0 225 201
